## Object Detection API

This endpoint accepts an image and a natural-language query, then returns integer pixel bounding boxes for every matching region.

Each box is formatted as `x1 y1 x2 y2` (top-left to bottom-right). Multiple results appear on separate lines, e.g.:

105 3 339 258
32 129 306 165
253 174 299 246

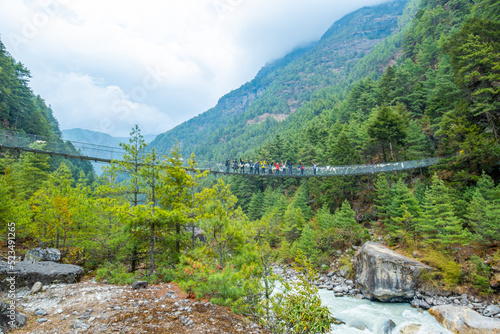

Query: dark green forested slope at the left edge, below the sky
0 41 93 178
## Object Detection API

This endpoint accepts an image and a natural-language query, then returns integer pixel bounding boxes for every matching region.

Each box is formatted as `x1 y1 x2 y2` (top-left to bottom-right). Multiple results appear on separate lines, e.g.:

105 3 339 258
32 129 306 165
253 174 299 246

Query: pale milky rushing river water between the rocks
319 289 451 334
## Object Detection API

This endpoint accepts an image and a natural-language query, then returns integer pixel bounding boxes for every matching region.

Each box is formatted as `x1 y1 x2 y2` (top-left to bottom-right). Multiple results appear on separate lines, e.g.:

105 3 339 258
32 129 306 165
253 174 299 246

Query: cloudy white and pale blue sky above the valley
0 0 384 136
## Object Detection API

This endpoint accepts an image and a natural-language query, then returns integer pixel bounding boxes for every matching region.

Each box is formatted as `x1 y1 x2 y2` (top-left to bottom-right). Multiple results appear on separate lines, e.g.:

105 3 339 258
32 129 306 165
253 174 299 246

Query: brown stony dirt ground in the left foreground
0 280 266 334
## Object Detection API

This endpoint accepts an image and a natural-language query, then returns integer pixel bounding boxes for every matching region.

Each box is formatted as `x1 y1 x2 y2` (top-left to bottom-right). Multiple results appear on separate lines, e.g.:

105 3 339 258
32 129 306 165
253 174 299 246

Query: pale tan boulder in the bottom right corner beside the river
429 305 500 334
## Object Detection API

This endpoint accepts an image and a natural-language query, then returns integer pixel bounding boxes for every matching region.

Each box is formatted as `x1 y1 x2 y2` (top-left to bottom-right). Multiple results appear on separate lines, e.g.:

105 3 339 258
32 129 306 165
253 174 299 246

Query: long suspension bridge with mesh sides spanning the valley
0 130 440 178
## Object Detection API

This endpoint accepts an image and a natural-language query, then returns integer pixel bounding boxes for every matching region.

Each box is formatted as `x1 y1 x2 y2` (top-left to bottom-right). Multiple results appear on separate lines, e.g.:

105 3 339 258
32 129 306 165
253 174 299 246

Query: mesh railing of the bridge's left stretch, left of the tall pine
0 130 125 160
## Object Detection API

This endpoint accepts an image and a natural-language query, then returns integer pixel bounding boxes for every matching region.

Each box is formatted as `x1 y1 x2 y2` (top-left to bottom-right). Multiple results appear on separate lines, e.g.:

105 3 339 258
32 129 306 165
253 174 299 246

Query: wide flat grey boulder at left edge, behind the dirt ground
0 261 84 290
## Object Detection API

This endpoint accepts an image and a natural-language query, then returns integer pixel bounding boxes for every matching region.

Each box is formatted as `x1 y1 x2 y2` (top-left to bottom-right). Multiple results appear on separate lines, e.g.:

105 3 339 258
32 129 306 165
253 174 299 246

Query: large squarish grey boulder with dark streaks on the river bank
354 242 432 302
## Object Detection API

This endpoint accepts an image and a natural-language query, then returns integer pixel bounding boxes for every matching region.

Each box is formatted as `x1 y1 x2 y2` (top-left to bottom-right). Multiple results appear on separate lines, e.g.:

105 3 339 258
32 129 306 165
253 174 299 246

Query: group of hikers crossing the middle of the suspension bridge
226 158 318 175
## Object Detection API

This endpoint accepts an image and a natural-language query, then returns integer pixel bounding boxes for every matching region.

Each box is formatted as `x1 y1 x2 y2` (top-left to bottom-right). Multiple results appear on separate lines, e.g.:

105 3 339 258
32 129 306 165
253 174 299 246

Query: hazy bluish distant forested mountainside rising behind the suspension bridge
151 0 418 160
